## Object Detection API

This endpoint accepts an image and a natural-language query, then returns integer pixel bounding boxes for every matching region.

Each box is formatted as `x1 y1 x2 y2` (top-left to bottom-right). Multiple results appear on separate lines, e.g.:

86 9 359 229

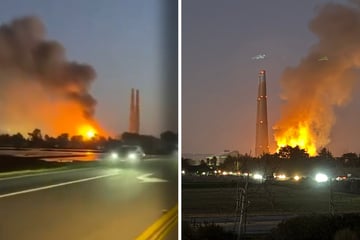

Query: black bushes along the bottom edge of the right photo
182 214 360 240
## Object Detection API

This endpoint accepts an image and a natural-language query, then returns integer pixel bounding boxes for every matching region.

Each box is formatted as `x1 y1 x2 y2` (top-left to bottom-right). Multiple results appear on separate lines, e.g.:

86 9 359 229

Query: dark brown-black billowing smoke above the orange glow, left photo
0 16 96 119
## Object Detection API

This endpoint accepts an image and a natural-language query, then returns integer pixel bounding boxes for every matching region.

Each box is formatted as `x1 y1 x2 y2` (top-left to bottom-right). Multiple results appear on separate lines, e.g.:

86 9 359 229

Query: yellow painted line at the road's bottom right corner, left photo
136 204 178 240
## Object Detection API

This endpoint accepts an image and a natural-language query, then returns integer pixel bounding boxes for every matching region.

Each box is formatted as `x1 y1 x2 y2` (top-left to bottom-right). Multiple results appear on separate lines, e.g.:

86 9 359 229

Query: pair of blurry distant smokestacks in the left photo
129 88 140 134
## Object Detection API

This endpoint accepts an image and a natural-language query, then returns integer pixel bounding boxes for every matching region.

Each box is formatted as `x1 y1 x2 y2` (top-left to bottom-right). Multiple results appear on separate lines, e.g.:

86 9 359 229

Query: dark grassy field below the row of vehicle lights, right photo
182 178 360 215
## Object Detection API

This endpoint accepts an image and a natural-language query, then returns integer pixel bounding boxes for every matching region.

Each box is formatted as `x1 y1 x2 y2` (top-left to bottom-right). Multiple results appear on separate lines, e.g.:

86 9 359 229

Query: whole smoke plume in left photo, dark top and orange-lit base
0 16 96 134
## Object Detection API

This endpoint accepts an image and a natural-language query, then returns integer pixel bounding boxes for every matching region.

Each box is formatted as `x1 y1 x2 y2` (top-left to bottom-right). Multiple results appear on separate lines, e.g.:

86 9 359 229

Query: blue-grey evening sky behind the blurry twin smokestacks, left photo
0 0 177 136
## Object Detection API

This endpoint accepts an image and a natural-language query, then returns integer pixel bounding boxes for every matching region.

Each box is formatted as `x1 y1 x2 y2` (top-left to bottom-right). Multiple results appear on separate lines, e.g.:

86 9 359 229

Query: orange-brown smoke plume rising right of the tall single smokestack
274 1 360 153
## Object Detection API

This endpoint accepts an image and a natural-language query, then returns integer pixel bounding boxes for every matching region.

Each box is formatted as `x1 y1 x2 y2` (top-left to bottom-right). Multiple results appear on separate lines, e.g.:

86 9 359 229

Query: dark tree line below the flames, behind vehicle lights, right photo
182 146 360 175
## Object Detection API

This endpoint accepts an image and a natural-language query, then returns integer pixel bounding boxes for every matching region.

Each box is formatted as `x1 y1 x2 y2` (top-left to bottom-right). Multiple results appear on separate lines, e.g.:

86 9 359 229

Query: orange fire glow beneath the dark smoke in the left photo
0 81 111 140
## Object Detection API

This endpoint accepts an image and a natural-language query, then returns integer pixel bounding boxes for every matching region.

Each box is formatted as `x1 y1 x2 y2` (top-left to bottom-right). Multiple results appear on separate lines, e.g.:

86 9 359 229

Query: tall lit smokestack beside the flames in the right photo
255 70 269 157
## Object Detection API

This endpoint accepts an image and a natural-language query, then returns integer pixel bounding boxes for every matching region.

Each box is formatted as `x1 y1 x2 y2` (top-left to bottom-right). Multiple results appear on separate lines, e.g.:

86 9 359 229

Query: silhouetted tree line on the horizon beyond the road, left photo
0 128 178 154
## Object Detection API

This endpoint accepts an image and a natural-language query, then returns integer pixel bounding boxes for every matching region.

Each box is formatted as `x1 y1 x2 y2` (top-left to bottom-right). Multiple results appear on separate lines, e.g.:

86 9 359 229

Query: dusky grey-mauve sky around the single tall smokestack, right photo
182 0 360 155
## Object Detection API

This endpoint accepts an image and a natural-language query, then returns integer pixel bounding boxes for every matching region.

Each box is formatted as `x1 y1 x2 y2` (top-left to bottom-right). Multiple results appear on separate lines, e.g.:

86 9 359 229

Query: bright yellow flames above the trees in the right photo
275 123 316 156
